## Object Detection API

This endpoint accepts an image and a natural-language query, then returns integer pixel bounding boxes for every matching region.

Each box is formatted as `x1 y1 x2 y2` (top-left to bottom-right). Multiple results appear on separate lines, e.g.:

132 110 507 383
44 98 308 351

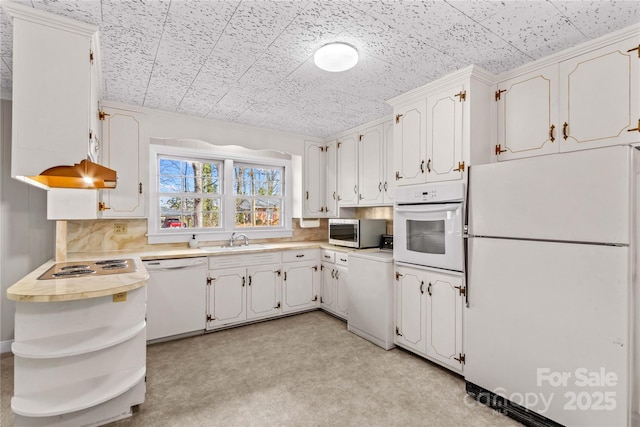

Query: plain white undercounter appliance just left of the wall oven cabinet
347 250 395 350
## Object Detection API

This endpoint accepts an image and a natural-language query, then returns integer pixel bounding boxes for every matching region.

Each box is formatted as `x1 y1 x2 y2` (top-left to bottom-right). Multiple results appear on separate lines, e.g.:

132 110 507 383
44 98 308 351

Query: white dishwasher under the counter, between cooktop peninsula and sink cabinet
143 257 207 341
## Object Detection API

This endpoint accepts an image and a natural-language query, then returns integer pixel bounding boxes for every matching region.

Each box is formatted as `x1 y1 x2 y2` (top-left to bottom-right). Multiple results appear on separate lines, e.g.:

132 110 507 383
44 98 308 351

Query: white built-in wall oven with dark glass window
393 182 465 272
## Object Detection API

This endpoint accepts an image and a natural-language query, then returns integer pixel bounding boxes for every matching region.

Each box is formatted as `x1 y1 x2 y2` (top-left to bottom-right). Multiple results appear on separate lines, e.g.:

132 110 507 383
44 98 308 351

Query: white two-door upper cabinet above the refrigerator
494 29 640 161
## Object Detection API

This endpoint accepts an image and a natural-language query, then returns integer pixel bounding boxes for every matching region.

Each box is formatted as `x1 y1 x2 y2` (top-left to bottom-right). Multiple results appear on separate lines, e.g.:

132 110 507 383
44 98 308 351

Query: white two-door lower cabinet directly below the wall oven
395 264 466 373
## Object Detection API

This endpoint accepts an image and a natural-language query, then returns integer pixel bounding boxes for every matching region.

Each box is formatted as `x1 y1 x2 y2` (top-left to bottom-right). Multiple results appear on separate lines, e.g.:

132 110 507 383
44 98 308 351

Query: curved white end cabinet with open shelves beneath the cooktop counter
11 286 146 427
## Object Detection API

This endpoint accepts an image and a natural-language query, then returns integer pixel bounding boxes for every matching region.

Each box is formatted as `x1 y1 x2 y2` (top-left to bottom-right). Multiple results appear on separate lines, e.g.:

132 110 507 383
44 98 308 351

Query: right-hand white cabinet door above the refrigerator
560 38 640 151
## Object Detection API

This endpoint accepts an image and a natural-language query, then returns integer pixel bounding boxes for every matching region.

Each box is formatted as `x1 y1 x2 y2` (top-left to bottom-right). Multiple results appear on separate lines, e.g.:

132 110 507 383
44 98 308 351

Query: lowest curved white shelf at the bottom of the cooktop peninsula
11 366 146 417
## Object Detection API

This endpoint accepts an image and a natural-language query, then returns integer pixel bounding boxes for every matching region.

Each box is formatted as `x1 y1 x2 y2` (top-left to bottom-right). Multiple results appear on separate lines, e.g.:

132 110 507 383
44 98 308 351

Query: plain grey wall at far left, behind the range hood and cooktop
0 100 55 352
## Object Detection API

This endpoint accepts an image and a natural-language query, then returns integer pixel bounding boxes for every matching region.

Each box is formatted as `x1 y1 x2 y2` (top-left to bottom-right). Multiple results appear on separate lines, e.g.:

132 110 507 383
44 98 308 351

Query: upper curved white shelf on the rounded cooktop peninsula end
11 320 146 359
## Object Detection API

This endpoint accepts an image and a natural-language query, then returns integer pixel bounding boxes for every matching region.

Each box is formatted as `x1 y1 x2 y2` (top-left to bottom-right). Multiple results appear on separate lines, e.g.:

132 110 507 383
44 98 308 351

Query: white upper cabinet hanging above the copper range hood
3 3 99 182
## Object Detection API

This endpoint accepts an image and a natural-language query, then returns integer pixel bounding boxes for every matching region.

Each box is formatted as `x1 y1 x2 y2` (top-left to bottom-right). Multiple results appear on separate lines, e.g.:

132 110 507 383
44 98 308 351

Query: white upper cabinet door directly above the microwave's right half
358 125 384 206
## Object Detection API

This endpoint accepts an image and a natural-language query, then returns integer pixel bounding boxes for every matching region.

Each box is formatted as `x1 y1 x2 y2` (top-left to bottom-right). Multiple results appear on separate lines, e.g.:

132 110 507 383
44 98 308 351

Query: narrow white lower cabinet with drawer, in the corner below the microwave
320 249 349 320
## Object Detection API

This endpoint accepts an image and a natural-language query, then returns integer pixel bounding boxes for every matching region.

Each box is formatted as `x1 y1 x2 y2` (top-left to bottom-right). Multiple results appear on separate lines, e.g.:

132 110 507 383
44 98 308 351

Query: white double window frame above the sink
147 144 294 244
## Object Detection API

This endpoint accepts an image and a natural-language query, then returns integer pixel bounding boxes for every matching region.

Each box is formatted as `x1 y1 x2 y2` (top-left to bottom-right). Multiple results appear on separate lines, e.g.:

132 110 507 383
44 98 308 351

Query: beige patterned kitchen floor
0 311 520 427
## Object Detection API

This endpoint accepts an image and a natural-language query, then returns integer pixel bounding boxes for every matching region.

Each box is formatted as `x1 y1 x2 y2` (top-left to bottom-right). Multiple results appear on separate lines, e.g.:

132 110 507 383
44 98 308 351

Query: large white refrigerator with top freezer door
464 146 640 427
